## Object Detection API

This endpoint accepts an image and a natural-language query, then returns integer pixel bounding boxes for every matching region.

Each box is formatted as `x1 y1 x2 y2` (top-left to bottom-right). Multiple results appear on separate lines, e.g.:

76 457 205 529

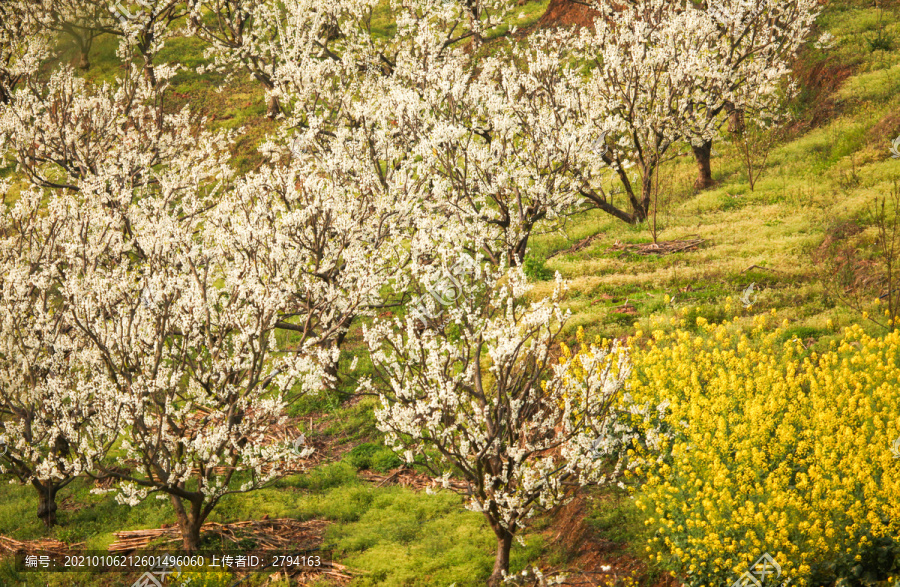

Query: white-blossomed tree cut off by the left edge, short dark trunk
0 182 122 527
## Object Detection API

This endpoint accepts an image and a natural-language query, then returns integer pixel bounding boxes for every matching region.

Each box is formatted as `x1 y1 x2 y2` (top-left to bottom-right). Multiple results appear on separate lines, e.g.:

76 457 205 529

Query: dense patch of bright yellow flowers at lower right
572 314 900 587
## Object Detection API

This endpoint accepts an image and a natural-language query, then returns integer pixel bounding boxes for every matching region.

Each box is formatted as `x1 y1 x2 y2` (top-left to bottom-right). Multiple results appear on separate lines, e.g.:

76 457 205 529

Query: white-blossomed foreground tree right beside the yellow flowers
364 255 629 585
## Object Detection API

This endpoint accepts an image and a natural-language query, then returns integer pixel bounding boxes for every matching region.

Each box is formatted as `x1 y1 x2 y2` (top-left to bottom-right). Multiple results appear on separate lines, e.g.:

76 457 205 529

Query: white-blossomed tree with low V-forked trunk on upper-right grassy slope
566 0 715 224
